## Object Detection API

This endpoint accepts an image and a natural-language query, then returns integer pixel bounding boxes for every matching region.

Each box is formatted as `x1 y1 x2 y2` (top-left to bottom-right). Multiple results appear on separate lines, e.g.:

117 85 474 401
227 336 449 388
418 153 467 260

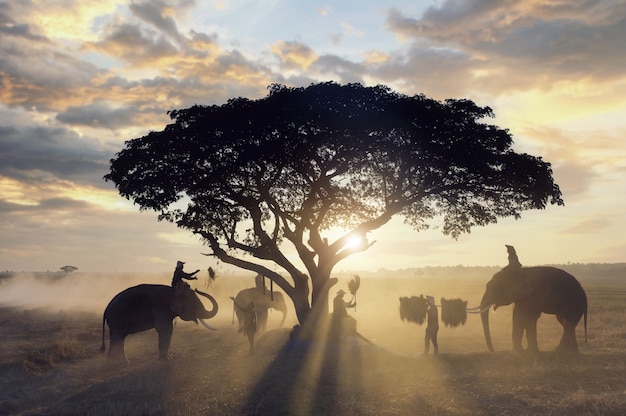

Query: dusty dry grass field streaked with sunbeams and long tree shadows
0 275 626 416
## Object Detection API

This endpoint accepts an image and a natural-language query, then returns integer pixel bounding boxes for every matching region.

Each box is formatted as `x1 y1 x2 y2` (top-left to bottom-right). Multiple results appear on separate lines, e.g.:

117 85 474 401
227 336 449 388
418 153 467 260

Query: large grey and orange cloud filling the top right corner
387 0 626 90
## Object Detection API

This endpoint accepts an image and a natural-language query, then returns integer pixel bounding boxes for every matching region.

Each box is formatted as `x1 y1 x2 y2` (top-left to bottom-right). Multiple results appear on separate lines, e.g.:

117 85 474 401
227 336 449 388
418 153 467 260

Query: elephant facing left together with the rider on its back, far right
480 246 587 353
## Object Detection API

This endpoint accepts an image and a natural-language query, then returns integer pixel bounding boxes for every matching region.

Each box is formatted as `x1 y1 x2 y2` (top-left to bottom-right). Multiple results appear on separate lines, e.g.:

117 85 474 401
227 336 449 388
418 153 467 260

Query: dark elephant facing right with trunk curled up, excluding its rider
100 282 218 363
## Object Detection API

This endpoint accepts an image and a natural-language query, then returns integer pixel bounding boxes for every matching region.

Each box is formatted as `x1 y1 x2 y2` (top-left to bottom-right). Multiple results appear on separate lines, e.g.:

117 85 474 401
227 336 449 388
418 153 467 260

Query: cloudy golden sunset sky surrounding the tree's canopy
0 0 626 273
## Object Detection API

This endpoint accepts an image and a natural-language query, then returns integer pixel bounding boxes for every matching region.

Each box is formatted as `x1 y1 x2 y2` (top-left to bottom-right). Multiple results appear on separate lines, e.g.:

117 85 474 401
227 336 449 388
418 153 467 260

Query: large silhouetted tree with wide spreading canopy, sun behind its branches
105 82 563 323
